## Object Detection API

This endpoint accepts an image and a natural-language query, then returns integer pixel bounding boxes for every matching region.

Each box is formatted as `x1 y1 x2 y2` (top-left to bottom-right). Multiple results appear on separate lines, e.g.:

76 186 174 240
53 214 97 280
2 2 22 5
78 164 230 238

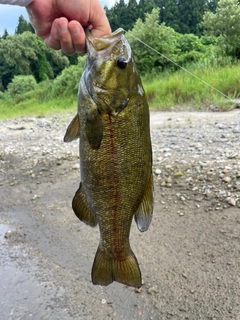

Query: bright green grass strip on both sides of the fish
0 64 240 120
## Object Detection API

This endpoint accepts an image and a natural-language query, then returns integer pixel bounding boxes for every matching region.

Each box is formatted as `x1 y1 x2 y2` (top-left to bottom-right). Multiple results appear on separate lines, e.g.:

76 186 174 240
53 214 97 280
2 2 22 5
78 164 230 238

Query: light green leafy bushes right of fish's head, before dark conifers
126 8 216 74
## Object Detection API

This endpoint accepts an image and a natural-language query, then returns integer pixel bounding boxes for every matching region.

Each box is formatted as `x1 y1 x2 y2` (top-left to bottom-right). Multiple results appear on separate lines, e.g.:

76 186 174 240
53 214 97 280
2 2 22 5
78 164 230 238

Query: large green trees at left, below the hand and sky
0 32 69 89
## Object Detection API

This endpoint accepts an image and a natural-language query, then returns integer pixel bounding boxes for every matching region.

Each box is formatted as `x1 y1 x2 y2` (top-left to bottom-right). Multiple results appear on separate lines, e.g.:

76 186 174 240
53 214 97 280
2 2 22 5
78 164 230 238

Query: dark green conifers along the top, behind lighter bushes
104 0 218 36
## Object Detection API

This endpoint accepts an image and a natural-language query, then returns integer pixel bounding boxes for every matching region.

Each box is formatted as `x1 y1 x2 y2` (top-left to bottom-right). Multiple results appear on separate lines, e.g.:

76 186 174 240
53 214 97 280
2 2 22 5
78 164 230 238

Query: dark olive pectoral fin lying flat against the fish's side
86 109 103 150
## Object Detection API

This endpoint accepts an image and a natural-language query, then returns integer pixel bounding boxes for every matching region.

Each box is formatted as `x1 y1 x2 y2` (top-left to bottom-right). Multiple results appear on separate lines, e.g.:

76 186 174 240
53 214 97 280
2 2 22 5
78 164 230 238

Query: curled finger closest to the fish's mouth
68 20 86 53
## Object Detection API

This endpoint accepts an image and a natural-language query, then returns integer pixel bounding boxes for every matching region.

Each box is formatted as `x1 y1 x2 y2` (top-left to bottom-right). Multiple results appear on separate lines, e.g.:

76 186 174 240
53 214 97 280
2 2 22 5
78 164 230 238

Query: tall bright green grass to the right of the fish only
143 65 240 110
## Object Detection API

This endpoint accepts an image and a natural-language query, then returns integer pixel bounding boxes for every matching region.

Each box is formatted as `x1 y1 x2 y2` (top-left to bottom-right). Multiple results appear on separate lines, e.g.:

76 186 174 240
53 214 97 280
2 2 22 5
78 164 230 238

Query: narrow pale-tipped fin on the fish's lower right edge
134 173 153 232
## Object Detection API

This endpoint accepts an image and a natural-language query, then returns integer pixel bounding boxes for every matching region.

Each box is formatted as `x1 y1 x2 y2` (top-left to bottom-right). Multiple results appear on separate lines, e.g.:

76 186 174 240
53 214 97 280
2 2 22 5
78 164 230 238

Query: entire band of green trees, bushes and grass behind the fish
0 0 240 119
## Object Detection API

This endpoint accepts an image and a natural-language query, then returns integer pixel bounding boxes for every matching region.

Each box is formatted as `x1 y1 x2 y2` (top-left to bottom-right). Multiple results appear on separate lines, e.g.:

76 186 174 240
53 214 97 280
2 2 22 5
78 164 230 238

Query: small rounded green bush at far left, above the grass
7 76 37 97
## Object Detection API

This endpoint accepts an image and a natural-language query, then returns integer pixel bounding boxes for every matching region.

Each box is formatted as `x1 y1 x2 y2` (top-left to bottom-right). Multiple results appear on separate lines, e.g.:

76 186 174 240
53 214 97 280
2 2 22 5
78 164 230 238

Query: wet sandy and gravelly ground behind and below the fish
0 110 240 320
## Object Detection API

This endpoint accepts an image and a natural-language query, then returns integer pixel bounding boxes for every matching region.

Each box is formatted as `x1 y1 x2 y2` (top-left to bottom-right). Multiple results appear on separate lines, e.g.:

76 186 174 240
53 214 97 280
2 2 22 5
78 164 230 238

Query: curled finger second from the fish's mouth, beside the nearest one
57 18 75 56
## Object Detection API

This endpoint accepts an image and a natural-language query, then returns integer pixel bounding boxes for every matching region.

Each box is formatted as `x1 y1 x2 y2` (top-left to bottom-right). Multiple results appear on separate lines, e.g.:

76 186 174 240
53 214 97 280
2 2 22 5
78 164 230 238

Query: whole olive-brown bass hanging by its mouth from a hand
64 28 154 288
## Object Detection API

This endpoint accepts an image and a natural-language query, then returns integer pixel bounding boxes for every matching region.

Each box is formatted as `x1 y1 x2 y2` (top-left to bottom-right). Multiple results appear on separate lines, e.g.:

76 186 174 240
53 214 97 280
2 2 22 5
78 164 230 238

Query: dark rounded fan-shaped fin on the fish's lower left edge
72 183 97 227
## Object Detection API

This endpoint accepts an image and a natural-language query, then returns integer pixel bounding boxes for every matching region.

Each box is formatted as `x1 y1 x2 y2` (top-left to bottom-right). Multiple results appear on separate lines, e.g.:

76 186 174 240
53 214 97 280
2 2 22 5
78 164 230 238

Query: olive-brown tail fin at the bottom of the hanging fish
92 247 142 288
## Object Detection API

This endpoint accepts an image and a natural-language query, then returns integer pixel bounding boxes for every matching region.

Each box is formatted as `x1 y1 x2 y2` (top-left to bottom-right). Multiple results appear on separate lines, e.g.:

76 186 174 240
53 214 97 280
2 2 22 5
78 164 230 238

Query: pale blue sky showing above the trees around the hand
0 0 116 35
